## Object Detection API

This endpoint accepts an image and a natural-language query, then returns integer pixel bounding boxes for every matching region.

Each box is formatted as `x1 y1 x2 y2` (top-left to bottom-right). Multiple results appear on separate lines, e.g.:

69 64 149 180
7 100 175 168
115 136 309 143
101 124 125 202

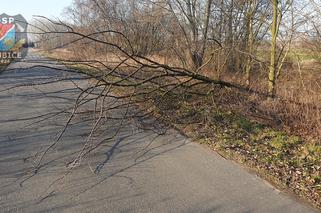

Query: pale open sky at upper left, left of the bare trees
0 0 72 21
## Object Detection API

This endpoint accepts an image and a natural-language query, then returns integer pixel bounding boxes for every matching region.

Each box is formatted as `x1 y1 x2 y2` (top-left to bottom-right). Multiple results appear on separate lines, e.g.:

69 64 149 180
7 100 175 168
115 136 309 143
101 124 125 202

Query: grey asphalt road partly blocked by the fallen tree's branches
0 55 317 213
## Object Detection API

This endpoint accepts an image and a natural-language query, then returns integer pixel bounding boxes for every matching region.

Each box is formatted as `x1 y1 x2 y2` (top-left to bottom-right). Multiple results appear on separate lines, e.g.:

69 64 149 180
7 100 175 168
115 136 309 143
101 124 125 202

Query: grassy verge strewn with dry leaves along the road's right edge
46 55 321 208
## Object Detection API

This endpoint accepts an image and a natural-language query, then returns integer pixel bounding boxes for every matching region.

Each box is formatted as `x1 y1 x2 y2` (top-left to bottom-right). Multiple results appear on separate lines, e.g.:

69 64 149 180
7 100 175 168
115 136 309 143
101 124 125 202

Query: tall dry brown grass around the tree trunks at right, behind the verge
200 62 321 139
